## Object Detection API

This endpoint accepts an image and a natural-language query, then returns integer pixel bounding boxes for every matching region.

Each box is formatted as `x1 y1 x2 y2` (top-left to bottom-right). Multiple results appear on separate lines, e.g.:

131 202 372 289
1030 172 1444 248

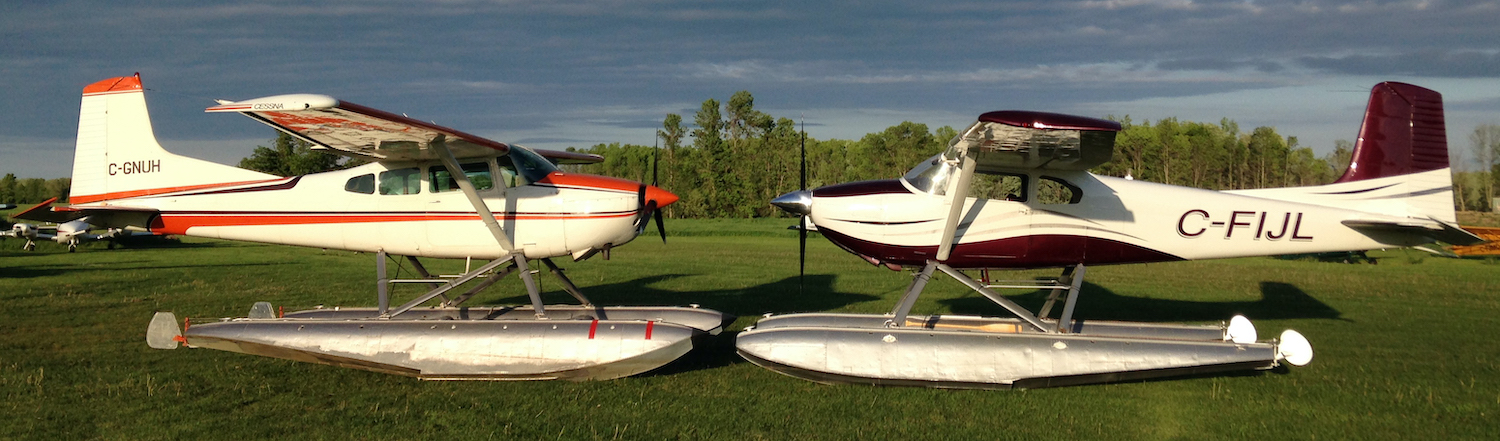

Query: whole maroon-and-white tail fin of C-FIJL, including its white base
1233 83 1457 224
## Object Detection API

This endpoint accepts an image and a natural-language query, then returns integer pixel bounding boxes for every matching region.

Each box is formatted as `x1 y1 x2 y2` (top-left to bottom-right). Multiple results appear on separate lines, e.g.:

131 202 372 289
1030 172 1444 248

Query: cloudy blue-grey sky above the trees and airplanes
0 0 1500 179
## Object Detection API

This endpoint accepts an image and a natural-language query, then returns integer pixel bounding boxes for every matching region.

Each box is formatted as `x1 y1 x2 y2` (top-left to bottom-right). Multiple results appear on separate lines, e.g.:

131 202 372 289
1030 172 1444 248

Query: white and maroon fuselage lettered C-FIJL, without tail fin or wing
809 165 1422 269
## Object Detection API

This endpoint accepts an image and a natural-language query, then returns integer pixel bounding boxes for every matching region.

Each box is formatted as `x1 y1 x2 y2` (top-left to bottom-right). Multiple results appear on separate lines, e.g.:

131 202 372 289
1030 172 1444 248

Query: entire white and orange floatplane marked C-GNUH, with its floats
20 75 726 380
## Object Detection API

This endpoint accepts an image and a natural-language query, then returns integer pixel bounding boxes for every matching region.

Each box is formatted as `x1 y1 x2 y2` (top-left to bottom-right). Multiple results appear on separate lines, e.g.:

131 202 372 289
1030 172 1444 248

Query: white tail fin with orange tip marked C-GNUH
69 74 278 204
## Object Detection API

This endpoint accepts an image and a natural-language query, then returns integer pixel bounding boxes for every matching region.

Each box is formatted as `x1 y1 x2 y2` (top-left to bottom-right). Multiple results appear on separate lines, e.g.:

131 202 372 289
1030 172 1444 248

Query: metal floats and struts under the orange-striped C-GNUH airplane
146 254 734 381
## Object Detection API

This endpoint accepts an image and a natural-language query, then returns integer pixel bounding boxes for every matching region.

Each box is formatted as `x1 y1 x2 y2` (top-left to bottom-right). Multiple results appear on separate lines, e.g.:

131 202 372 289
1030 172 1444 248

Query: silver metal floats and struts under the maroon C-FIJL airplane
735 264 1313 389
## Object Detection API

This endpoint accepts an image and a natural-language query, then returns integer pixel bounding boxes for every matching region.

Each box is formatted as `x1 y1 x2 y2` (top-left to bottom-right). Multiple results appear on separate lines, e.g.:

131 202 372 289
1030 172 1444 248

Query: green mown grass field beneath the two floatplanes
0 219 1500 440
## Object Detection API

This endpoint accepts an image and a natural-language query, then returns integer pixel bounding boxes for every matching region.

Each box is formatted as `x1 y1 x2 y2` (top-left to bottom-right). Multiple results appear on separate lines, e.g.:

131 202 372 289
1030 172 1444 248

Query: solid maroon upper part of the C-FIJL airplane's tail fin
1337 83 1448 182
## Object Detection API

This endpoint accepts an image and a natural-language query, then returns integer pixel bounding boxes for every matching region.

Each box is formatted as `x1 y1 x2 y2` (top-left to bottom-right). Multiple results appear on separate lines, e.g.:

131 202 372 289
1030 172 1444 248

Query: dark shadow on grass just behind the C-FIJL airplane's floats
938 282 1341 323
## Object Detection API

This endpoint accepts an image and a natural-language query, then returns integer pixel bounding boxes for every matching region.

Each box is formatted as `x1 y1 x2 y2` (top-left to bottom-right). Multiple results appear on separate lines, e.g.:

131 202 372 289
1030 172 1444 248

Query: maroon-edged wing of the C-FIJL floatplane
944 111 1121 171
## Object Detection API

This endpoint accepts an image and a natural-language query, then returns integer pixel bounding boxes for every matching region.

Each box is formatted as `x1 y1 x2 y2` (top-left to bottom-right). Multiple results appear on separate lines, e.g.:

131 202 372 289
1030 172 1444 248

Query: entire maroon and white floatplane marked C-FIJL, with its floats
737 83 1482 389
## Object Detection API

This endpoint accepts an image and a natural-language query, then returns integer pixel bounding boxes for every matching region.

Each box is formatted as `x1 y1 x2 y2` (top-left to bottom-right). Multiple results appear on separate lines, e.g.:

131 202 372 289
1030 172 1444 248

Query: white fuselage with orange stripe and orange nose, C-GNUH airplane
75 147 677 258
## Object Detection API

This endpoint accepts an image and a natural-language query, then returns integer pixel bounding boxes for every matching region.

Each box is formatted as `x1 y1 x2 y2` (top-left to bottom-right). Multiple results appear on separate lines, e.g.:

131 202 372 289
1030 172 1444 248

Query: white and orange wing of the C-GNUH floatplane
206 95 603 164
